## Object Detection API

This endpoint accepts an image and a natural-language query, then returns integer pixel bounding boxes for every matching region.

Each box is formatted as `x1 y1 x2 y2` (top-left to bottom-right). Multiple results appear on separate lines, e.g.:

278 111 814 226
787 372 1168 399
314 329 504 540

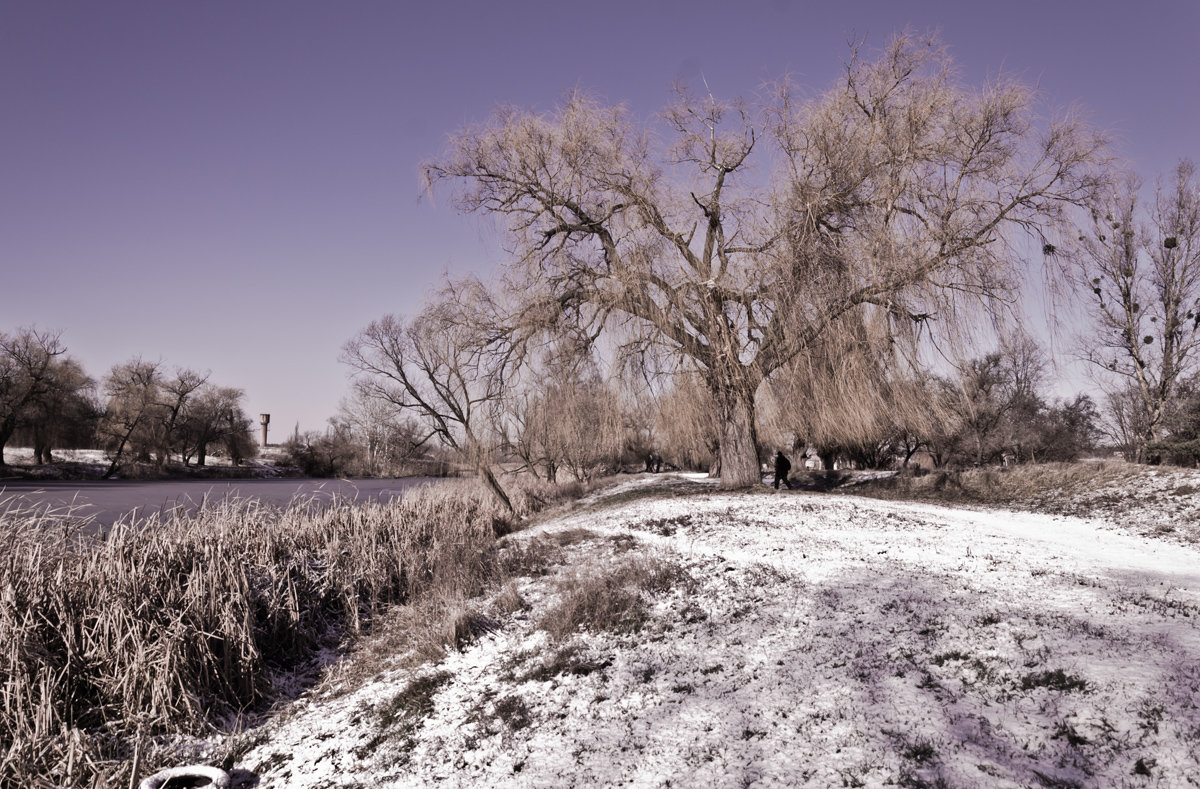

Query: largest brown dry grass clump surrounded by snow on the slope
539 558 686 639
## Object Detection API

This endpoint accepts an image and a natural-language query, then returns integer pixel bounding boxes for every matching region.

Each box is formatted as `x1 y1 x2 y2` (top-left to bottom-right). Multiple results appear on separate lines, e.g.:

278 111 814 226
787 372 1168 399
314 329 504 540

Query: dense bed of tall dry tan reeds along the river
0 483 552 787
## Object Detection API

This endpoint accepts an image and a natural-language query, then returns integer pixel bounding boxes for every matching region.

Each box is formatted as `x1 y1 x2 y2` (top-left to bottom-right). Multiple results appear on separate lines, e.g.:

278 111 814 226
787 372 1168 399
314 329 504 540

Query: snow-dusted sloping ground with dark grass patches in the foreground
239 475 1200 788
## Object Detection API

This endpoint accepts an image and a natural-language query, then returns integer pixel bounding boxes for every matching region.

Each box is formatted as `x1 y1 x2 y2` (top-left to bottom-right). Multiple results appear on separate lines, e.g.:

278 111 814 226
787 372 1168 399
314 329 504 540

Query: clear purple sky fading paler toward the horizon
0 0 1200 442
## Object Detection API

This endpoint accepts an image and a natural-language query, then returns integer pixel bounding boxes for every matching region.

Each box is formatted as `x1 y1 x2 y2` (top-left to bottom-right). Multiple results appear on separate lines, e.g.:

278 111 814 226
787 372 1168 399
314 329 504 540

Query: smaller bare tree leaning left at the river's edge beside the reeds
342 283 512 512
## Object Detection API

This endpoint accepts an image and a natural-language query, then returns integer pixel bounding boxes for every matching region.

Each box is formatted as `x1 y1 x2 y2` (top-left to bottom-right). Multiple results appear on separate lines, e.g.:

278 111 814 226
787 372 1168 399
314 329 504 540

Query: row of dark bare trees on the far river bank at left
0 327 258 476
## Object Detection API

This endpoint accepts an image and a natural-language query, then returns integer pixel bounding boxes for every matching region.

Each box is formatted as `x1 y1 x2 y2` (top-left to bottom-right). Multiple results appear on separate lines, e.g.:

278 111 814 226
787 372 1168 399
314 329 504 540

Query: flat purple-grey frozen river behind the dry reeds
0 477 439 531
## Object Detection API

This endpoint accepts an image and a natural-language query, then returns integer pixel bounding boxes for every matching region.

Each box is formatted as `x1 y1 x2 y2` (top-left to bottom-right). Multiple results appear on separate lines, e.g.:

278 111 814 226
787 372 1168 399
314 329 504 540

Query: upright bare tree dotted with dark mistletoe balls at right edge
1063 159 1200 460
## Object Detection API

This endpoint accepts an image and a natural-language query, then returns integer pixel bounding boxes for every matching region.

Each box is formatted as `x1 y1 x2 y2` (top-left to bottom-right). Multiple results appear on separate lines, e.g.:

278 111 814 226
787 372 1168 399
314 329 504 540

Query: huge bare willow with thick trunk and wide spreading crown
425 35 1103 488
